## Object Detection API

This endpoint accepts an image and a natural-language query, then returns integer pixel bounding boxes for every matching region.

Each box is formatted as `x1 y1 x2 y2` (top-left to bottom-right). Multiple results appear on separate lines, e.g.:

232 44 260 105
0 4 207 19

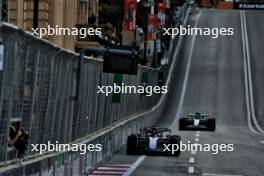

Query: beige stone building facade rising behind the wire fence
0 0 99 51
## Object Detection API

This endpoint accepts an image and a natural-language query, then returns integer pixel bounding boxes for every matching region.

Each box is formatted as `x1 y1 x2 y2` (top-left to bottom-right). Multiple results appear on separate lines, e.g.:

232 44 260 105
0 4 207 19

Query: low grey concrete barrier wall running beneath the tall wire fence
0 3 188 175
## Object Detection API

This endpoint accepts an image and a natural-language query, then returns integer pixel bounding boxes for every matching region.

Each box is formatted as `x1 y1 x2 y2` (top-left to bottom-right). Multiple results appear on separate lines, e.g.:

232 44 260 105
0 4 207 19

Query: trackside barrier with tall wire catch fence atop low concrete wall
0 4 188 176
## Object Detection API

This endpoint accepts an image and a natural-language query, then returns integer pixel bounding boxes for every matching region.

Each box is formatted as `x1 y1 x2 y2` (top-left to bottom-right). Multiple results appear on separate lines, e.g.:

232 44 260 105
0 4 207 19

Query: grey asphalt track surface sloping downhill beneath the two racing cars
93 10 264 176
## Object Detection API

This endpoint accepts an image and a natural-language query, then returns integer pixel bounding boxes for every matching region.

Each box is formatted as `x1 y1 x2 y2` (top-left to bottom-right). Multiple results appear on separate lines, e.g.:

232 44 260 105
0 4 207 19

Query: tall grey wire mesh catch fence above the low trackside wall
0 23 160 161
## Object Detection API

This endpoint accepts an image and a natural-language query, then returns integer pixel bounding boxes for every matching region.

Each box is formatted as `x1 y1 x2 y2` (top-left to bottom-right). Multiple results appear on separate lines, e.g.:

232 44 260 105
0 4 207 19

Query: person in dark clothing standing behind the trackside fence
8 122 29 158
